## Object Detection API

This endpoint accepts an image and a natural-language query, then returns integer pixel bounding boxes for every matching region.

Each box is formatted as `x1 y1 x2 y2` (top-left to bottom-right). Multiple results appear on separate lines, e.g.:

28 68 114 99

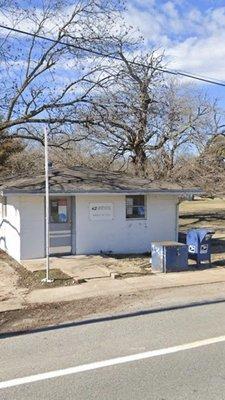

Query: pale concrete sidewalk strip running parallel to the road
26 267 225 304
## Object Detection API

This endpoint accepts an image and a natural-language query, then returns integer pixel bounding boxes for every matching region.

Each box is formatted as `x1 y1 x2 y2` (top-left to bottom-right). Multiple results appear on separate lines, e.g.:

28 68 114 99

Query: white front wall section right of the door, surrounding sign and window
76 195 178 254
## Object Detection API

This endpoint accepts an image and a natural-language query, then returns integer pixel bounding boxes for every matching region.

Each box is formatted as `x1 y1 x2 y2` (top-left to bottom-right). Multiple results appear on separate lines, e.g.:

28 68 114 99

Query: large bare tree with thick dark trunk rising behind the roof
87 44 213 175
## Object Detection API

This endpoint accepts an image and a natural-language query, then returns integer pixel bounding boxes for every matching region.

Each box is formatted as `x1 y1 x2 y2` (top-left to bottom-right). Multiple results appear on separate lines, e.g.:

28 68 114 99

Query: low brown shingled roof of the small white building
0 166 200 195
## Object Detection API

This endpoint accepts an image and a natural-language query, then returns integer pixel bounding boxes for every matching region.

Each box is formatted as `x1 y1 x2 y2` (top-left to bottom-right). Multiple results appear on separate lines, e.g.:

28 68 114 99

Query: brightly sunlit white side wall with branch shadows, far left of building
0 196 21 261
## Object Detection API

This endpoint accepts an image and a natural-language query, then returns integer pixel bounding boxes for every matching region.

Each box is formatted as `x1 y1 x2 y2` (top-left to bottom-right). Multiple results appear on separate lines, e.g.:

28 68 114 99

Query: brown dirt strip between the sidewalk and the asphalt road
0 283 225 336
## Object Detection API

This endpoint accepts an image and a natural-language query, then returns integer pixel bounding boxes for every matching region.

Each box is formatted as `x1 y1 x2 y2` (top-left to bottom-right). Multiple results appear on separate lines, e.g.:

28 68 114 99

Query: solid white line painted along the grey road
0 336 225 389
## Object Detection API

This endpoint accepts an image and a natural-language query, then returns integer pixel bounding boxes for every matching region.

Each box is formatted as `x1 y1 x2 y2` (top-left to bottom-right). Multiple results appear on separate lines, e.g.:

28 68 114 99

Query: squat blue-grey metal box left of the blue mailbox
151 241 188 272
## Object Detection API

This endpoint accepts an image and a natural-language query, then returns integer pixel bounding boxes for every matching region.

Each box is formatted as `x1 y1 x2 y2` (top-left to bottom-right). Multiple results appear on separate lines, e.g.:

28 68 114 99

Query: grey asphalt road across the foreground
0 303 225 400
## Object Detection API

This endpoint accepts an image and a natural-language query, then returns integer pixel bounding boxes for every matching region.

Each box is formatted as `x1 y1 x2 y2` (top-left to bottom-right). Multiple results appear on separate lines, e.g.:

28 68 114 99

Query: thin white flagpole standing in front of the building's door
42 127 53 283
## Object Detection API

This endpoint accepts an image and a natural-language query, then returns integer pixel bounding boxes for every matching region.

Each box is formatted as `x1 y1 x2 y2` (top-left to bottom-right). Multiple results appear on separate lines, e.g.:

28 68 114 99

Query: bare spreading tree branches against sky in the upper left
0 0 132 142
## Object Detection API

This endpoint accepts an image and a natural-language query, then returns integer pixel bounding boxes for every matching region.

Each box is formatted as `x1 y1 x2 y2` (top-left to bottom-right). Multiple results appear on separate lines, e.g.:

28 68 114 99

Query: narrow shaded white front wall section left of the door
20 195 45 260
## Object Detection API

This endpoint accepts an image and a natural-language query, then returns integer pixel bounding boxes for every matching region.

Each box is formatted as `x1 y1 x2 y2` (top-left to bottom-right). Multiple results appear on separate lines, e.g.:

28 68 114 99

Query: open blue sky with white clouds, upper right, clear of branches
126 0 225 104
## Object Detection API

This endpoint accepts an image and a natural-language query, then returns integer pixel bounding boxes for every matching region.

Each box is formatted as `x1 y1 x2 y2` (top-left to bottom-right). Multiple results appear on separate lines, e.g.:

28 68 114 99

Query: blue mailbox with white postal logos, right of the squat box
186 228 215 265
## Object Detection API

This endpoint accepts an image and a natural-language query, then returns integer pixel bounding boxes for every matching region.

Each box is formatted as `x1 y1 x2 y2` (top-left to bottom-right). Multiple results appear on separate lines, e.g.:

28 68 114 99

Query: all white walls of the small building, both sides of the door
0 195 178 261
